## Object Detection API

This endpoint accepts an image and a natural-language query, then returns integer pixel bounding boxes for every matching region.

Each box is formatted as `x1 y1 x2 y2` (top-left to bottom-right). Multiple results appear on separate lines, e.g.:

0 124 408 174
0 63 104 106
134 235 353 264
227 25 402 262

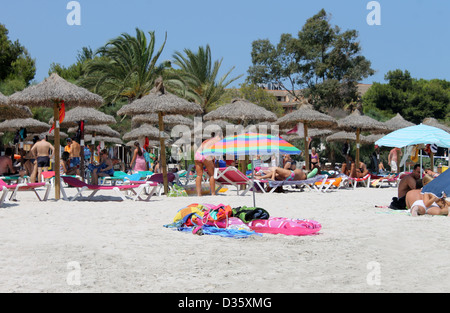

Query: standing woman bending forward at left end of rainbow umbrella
194 133 222 197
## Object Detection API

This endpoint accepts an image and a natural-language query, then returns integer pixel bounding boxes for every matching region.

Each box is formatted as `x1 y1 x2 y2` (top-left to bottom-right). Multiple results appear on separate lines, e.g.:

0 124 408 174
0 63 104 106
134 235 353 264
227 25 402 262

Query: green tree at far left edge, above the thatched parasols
0 24 36 95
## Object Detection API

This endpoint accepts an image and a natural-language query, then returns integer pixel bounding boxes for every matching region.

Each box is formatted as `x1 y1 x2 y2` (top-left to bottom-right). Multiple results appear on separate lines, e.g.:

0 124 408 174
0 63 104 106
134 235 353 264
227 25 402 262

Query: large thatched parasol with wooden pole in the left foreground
8 73 103 200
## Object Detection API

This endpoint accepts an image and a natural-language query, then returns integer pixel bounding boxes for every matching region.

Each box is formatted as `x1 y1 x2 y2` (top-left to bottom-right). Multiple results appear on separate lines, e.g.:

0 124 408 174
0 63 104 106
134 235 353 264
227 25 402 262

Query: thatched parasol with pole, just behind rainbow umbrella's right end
276 104 337 170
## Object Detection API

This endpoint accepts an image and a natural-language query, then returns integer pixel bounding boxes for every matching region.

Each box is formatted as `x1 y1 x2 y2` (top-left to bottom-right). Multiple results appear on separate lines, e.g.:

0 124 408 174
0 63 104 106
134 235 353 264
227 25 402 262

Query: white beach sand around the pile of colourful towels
0 183 450 293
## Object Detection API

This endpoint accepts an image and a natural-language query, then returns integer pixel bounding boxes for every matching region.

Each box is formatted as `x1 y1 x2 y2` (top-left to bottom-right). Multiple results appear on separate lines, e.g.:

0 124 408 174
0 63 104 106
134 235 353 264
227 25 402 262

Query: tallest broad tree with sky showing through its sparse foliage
247 9 374 108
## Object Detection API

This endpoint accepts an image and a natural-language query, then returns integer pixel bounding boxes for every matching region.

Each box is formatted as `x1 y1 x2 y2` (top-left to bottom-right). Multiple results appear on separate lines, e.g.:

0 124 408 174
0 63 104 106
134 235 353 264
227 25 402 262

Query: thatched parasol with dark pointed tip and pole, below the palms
117 78 203 195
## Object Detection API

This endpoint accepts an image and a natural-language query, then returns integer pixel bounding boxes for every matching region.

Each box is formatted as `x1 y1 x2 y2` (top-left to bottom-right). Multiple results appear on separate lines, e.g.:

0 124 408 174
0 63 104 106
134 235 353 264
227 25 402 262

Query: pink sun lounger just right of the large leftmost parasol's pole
61 176 153 201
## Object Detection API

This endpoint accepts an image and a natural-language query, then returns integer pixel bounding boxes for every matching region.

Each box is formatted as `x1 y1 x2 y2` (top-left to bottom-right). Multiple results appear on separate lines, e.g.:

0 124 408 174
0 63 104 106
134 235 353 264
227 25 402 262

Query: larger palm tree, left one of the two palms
80 28 168 103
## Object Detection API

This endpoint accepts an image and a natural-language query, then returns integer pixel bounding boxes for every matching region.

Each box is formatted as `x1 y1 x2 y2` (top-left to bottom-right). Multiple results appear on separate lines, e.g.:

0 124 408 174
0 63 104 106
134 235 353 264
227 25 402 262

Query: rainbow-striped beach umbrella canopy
202 133 301 156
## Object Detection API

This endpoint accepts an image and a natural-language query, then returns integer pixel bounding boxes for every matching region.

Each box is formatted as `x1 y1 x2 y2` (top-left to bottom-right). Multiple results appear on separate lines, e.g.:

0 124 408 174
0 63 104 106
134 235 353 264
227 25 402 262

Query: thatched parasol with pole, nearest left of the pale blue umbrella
338 109 389 168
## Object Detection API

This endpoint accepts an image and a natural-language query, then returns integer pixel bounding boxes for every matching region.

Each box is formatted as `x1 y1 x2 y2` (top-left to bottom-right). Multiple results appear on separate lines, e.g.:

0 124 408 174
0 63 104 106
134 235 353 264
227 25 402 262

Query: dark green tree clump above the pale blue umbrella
363 70 450 124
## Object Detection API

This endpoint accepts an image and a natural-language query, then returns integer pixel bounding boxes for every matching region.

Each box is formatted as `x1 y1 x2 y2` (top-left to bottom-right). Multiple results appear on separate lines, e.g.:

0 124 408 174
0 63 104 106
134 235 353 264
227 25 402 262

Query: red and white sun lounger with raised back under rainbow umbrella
214 166 268 196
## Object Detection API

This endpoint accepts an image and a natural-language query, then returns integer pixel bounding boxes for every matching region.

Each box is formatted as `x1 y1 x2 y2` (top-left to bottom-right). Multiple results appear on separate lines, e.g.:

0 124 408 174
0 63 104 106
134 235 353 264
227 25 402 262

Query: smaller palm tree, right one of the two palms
173 45 242 112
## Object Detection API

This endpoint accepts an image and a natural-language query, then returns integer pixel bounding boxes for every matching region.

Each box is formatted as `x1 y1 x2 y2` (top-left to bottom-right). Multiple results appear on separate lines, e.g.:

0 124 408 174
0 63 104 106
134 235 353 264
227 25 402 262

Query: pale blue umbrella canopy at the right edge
375 124 450 148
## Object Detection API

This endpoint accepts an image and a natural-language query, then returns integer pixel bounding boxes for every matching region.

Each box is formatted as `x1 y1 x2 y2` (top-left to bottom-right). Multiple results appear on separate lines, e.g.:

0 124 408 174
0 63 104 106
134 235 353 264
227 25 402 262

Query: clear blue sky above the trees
0 0 450 85
